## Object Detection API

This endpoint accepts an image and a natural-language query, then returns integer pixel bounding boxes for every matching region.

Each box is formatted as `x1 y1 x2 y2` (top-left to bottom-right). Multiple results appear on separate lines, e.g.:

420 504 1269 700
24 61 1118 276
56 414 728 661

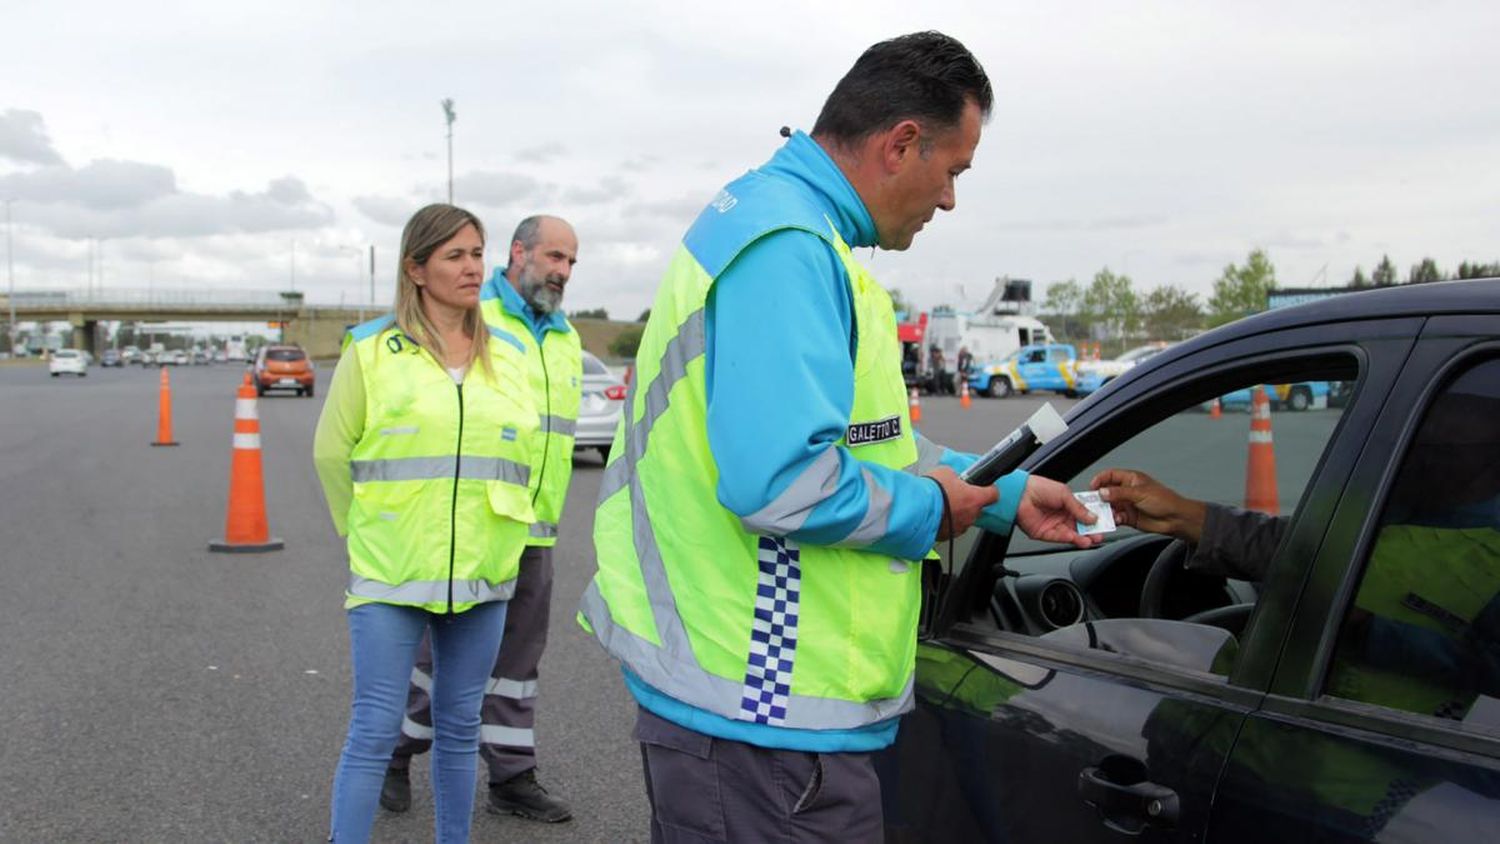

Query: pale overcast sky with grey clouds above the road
0 0 1500 318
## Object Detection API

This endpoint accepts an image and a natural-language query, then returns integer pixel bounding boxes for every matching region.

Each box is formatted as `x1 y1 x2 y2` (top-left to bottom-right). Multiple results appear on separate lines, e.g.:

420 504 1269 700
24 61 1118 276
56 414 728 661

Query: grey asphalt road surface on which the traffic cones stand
0 366 1338 843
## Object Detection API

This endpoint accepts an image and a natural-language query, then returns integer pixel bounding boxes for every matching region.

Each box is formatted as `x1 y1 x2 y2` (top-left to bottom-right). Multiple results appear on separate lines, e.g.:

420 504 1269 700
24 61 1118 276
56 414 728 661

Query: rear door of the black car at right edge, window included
1211 315 1500 843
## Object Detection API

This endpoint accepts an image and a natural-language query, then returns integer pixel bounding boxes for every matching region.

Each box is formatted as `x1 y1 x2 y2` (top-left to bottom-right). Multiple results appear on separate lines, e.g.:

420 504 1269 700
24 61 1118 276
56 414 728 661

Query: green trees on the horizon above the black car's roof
1041 249 1500 340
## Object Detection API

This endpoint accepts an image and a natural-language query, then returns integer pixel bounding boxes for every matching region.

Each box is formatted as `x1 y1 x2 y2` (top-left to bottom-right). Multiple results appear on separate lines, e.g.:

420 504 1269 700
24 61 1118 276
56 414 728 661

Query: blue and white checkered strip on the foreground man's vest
740 537 803 727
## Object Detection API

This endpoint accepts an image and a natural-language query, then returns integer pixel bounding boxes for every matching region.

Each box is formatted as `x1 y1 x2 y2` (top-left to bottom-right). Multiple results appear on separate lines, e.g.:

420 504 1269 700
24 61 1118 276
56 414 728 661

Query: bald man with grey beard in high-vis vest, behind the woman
381 216 584 823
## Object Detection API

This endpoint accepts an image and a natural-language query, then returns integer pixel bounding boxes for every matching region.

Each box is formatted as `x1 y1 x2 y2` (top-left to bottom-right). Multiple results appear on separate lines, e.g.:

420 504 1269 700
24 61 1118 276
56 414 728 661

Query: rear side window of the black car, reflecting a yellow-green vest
1325 360 1500 735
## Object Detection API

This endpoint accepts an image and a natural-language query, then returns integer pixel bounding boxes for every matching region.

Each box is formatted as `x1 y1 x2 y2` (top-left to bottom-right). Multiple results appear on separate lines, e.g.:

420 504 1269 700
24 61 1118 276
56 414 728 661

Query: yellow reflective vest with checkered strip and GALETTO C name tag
581 180 921 730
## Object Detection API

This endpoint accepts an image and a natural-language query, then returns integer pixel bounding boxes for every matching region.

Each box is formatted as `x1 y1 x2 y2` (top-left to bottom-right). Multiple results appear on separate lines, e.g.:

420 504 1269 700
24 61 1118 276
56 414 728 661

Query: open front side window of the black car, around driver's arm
995 355 1358 676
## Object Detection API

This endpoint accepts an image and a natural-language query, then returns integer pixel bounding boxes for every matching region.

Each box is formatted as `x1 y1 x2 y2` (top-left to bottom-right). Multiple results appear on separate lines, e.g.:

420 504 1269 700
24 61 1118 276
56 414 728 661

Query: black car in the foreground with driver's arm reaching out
876 279 1500 844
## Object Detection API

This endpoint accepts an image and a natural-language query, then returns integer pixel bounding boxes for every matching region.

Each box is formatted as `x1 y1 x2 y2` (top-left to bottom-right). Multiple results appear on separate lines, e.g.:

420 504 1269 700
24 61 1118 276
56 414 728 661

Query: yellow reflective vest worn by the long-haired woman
347 316 537 613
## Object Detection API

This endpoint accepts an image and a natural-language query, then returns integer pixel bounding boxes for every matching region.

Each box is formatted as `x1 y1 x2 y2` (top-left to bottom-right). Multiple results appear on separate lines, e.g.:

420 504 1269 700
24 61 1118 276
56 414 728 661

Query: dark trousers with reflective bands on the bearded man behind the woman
390 546 552 784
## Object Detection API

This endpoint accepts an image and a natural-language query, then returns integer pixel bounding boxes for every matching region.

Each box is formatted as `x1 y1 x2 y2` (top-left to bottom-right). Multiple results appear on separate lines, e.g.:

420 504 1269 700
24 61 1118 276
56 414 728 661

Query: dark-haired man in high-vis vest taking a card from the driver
581 33 1095 841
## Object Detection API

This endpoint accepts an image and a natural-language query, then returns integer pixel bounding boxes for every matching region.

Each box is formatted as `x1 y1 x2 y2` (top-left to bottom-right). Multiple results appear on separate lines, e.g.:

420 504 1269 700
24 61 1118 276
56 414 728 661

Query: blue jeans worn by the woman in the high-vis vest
330 601 506 844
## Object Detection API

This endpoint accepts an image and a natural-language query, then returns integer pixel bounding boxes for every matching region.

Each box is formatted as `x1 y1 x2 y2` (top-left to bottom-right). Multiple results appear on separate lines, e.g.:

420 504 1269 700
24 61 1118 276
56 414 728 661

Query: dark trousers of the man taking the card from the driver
635 709 885 844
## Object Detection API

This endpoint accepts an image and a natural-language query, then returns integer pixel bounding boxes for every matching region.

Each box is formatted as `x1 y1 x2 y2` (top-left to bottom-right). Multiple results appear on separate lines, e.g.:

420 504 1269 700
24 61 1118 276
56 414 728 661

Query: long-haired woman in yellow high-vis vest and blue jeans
314 205 537 844
